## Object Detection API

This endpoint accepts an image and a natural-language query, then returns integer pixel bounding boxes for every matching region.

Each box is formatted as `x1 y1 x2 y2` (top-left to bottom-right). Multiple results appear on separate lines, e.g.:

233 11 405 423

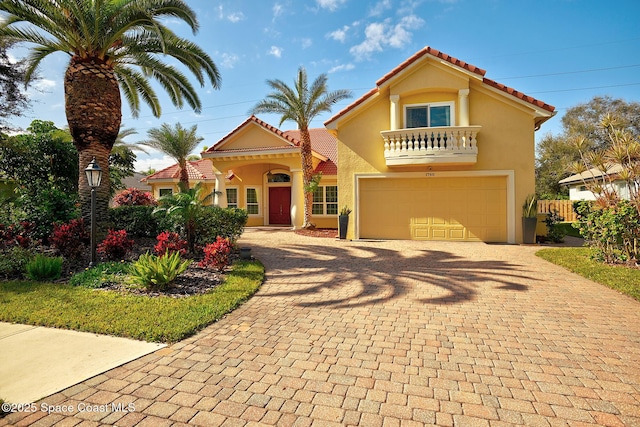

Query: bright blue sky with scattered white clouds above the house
5 0 640 170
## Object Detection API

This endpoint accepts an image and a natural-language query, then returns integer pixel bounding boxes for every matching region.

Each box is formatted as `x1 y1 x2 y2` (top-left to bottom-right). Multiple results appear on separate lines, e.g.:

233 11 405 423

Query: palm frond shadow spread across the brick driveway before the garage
242 237 532 308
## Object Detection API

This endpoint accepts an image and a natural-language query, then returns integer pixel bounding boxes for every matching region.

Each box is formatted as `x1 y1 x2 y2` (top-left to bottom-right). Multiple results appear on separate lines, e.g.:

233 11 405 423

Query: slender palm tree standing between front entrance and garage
251 67 351 228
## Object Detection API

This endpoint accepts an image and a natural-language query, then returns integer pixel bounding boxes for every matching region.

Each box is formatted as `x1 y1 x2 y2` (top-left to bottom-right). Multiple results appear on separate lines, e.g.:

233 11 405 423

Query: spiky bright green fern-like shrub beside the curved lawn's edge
130 252 191 290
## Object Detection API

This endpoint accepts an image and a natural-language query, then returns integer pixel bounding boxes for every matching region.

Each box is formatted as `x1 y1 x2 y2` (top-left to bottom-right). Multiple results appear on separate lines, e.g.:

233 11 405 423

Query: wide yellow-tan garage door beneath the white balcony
359 176 507 242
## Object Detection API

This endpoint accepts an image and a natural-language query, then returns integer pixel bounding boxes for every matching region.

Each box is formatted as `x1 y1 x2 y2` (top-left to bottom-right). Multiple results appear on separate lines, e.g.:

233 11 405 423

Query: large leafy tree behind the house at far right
536 96 640 199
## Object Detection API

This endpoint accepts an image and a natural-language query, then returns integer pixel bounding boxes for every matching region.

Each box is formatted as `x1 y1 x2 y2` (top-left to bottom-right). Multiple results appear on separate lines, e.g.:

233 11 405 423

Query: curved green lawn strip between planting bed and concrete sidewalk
0 261 264 343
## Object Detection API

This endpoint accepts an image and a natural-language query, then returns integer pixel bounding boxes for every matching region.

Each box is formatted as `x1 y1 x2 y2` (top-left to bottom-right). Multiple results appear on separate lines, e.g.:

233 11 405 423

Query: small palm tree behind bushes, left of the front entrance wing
139 123 204 191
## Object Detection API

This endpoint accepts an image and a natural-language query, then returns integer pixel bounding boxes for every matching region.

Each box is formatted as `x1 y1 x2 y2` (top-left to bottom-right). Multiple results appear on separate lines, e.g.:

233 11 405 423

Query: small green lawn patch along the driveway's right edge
536 248 640 301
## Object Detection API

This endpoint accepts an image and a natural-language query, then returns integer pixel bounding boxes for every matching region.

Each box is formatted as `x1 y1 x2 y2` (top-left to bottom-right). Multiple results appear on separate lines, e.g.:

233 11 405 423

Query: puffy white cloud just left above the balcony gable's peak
349 15 424 61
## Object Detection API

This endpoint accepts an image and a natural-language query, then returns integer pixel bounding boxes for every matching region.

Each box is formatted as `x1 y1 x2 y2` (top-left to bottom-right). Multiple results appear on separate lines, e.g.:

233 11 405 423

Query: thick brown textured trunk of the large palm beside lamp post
64 57 122 223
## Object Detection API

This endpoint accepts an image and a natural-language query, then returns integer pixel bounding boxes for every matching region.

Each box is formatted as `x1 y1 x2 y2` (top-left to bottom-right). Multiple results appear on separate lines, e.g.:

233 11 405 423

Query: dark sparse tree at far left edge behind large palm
0 40 29 130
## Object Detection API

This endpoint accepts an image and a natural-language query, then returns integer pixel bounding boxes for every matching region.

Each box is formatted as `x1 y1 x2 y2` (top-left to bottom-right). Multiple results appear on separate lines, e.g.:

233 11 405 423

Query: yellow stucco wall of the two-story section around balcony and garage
334 61 548 242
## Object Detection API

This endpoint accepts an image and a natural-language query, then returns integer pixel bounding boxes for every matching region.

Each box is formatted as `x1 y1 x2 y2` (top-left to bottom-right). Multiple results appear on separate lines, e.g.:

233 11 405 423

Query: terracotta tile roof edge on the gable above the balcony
324 46 555 126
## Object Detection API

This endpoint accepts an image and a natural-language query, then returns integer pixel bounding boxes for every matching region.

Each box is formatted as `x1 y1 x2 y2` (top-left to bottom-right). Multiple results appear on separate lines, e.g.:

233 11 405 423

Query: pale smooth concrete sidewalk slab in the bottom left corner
0 322 165 403
